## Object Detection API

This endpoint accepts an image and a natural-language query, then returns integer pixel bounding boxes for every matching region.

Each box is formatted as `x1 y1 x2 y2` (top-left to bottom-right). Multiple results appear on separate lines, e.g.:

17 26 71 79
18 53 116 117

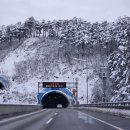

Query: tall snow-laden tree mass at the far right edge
108 17 130 101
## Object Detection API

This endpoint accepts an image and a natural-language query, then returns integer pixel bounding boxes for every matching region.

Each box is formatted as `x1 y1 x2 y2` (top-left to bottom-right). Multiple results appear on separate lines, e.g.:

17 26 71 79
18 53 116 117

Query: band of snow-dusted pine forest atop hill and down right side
0 17 130 101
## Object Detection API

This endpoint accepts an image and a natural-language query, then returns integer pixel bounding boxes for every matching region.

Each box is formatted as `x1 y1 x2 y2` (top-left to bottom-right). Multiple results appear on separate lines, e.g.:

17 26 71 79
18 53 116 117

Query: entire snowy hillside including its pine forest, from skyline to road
0 16 130 103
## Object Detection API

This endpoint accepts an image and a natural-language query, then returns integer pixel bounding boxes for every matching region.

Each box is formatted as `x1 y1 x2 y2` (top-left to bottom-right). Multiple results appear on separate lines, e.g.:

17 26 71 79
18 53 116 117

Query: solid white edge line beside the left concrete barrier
0 109 45 124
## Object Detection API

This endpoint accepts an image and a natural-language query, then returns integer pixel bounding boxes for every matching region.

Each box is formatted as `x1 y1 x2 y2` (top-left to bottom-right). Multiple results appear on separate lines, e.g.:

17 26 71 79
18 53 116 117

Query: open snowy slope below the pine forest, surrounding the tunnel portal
0 38 98 103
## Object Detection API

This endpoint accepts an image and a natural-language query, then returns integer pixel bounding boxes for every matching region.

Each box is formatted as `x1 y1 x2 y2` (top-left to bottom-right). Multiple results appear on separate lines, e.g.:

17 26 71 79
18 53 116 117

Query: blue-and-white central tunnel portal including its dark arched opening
37 88 75 108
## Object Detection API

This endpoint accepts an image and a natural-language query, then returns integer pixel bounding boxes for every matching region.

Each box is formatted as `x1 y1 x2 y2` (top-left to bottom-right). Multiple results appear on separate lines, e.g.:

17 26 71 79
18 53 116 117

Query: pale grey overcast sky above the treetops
0 0 130 25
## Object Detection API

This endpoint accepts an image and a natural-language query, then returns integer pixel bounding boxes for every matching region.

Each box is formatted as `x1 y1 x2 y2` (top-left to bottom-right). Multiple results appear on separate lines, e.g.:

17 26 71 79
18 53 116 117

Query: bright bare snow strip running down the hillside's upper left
0 38 37 76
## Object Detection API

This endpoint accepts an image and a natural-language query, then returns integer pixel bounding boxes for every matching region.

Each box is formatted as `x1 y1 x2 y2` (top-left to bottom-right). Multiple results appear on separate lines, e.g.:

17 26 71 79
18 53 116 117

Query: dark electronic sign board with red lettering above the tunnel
40 82 66 88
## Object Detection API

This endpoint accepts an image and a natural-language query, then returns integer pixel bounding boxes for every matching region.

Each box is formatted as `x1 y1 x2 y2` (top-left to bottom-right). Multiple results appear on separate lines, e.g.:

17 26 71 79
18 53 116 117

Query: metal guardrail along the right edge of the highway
74 102 130 109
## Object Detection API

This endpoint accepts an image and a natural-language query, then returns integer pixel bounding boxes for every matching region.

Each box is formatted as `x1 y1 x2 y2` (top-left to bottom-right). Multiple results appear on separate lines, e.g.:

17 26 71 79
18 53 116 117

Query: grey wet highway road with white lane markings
0 108 130 130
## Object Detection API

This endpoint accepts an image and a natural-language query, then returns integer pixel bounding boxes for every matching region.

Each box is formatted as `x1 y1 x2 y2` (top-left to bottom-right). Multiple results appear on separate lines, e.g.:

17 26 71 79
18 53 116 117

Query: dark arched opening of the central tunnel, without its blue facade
42 92 69 108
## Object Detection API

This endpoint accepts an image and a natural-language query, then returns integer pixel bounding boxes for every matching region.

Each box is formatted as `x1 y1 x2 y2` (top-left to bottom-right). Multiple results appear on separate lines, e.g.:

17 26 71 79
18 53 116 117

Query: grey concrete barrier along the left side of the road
0 104 42 115
